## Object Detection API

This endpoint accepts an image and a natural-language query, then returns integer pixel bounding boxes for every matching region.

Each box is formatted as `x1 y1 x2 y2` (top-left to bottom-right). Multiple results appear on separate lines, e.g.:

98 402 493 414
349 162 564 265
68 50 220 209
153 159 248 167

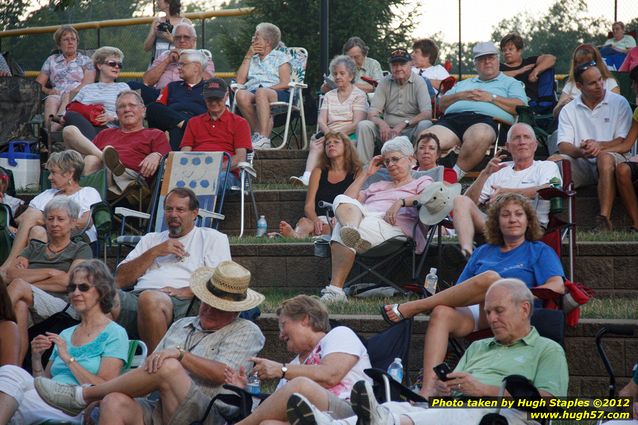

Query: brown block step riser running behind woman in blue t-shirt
231 242 638 297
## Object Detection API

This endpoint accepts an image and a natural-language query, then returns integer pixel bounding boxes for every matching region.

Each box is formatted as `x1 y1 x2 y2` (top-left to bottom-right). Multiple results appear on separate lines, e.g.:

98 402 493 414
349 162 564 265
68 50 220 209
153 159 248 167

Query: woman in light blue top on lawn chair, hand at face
236 22 291 149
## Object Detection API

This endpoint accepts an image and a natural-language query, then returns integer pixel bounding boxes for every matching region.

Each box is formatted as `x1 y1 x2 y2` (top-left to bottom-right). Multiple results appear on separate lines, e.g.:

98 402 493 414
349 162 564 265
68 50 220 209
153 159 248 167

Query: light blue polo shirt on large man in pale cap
445 72 527 124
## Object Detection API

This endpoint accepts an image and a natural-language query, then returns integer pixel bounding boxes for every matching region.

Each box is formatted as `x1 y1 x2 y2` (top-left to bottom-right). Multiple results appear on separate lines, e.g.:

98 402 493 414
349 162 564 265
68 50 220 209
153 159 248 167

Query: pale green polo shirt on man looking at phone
454 327 569 397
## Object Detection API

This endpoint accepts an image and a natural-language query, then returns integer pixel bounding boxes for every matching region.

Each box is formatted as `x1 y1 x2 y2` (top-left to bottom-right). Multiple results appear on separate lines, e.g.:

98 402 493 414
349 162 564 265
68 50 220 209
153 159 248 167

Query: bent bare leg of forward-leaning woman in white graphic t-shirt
237 377 336 425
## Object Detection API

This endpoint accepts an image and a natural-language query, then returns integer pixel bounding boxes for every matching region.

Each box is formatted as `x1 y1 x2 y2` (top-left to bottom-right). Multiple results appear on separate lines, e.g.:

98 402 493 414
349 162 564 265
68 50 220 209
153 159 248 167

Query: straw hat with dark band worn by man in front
190 261 264 311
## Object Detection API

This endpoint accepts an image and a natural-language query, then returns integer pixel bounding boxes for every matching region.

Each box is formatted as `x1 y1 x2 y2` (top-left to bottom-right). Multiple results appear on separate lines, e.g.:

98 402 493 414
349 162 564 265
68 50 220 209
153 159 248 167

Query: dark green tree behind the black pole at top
220 0 418 88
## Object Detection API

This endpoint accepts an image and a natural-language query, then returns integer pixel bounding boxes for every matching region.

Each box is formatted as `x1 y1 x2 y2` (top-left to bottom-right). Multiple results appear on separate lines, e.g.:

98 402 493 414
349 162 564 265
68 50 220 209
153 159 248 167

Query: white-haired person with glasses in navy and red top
146 49 208 151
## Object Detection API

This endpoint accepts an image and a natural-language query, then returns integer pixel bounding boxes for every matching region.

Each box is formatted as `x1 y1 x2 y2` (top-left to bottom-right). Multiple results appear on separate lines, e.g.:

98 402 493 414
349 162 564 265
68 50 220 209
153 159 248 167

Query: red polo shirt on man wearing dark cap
179 110 253 157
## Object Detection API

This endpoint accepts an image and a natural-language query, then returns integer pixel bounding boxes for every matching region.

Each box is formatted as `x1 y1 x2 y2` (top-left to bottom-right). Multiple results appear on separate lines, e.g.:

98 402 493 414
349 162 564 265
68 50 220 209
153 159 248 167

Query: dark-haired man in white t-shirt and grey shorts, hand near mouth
113 188 230 351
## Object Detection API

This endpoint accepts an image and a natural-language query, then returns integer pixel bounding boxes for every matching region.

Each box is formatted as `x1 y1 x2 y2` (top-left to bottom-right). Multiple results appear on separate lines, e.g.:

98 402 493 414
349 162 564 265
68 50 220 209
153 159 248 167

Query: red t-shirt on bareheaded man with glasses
93 128 171 173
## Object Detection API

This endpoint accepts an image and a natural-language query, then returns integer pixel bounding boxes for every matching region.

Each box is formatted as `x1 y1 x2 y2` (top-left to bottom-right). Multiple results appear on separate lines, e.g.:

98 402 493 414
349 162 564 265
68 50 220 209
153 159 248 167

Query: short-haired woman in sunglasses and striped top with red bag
59 46 130 140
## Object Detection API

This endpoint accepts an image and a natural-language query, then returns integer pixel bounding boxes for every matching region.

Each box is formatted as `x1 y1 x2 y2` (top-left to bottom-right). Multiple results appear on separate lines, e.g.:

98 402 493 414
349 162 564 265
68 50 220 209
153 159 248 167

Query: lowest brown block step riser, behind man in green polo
257 314 638 397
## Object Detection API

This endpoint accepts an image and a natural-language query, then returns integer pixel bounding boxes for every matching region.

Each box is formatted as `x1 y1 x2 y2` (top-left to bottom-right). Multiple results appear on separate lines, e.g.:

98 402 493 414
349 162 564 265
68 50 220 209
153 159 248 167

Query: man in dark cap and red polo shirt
180 78 253 189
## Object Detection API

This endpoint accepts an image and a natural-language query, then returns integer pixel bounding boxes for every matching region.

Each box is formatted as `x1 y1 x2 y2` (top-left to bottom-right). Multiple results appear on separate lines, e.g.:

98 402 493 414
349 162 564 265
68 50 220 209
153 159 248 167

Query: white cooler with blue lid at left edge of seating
0 140 40 191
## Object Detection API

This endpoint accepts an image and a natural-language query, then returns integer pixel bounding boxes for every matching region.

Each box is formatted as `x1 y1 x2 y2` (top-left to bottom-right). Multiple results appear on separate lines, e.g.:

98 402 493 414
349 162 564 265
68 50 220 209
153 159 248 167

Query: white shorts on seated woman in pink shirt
331 195 404 251
